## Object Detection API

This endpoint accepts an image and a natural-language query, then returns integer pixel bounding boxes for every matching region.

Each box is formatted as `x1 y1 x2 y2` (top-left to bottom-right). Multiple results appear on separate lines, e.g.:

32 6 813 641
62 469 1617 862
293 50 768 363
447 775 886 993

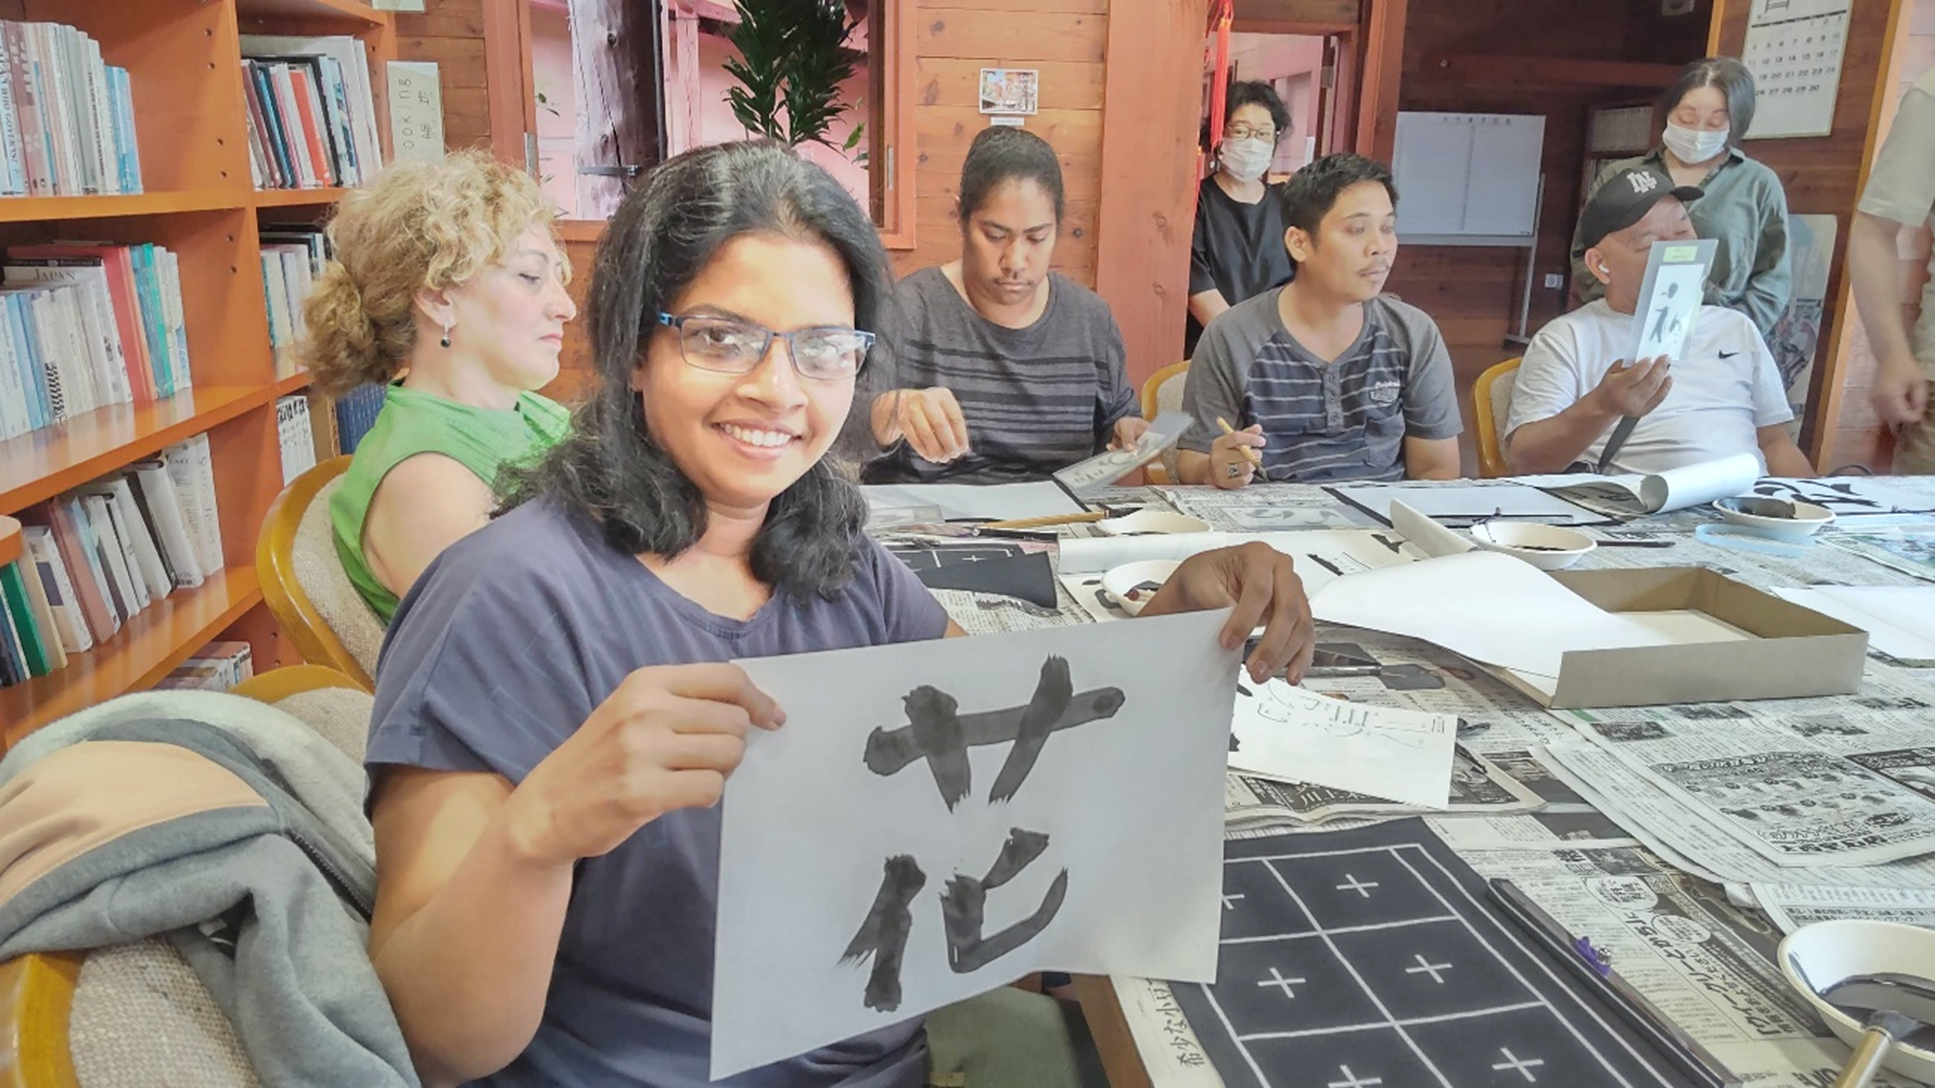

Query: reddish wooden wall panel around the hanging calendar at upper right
1714 0 1916 470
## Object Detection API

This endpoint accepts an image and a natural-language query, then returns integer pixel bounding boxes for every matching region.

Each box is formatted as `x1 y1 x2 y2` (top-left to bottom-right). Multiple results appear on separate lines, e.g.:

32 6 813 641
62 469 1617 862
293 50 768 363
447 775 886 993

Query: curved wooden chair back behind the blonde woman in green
255 457 383 691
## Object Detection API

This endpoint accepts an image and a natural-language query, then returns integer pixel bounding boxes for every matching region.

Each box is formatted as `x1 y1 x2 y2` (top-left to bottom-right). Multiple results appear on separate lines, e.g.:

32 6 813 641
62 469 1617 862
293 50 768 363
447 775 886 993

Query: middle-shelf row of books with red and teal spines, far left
0 244 190 439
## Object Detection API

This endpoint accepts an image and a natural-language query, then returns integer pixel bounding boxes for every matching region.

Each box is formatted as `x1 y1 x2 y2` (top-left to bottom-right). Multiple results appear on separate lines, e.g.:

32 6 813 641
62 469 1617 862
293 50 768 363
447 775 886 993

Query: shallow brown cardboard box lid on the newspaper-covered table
1502 567 1867 710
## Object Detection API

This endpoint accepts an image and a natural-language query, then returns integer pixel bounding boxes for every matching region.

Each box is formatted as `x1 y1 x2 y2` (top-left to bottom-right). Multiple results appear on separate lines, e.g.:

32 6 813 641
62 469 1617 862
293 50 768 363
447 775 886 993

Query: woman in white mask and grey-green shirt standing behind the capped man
1573 56 1794 339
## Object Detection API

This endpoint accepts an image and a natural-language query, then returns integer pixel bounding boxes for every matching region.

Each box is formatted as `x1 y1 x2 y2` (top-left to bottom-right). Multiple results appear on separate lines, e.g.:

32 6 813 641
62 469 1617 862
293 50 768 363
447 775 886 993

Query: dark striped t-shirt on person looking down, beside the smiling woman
867 267 1136 484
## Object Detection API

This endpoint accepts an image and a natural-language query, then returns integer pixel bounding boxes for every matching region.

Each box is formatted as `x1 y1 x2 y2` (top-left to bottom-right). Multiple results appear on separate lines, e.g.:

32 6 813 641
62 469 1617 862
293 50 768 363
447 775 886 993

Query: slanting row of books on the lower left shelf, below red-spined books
0 434 223 687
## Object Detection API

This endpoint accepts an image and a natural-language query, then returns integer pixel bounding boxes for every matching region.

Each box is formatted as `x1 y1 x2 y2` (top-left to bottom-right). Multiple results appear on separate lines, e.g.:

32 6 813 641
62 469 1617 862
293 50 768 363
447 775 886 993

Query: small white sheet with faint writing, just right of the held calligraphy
1229 680 1457 809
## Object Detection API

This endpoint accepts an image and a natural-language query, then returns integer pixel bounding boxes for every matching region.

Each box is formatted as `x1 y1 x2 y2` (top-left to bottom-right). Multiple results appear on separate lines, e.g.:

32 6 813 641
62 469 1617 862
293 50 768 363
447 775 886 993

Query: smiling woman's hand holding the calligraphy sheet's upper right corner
1142 542 1316 683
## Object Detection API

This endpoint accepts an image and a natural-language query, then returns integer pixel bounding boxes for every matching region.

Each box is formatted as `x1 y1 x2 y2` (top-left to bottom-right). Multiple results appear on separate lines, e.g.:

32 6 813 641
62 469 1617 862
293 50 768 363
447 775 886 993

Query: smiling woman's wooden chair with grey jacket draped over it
0 664 372 1088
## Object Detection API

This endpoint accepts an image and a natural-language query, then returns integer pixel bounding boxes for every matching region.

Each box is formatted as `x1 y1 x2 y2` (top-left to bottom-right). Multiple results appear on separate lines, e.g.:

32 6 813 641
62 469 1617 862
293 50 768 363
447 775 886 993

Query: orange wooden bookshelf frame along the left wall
0 0 397 743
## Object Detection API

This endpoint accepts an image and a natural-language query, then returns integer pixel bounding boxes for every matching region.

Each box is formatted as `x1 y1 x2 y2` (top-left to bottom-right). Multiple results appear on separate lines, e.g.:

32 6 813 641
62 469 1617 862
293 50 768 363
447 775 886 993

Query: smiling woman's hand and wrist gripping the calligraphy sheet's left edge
505 664 786 865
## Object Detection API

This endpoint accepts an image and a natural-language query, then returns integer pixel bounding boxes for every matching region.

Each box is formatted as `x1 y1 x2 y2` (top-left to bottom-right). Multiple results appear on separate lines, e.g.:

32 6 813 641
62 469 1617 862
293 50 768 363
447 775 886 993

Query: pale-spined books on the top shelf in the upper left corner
0 21 141 196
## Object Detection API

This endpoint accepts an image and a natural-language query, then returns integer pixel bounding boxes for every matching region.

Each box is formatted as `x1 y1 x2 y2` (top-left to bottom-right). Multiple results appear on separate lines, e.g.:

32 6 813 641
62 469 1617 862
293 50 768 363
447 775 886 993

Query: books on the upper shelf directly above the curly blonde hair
242 35 381 190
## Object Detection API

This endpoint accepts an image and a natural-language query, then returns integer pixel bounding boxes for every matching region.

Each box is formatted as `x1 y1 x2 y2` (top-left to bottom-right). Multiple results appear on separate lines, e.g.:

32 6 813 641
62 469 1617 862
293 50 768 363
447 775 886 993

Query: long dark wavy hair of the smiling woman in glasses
501 139 892 598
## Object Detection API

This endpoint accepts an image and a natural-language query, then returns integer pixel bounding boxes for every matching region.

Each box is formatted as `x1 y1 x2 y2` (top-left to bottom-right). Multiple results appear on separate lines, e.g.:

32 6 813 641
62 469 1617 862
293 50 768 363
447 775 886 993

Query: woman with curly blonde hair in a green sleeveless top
300 153 577 623
